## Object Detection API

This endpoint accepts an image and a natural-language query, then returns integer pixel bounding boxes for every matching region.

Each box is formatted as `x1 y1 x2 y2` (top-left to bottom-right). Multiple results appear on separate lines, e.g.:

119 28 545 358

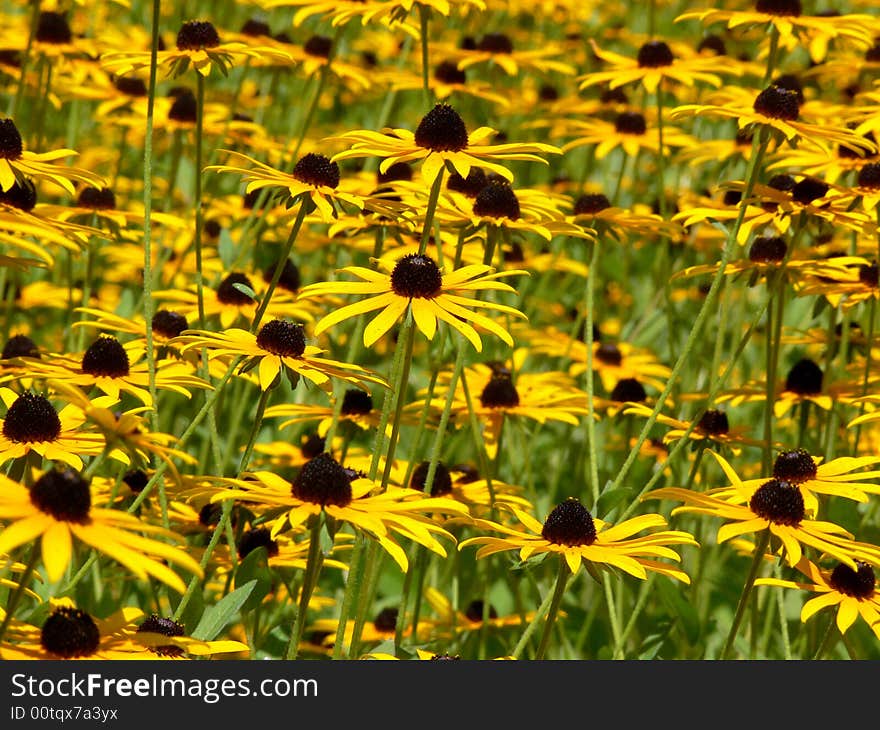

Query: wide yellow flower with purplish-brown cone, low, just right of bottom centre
459 497 698 583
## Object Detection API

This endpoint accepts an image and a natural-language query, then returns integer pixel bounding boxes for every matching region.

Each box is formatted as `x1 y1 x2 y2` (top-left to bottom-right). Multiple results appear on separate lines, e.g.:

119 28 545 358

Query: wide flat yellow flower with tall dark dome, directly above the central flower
330 104 562 184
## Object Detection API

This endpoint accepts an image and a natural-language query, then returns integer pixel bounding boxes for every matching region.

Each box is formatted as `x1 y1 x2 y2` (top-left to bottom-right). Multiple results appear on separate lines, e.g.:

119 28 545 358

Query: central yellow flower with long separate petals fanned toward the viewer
300 253 527 352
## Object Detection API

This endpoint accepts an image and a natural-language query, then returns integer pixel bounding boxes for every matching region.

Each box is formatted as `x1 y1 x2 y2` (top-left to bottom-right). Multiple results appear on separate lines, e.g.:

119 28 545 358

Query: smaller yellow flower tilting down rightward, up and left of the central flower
205 150 364 223
